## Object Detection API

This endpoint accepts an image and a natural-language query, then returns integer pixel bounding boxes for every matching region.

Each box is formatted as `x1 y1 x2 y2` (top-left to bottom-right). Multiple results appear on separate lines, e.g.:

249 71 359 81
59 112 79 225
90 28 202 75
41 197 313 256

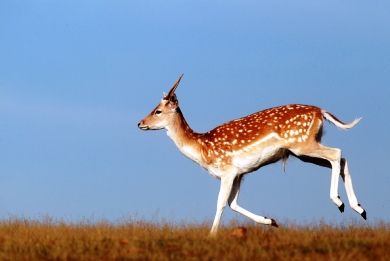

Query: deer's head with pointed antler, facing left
138 74 183 130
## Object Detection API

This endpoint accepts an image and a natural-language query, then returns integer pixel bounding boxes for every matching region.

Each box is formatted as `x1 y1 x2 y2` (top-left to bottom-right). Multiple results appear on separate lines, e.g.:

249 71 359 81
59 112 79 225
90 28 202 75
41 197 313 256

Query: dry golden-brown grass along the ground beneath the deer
0 215 390 261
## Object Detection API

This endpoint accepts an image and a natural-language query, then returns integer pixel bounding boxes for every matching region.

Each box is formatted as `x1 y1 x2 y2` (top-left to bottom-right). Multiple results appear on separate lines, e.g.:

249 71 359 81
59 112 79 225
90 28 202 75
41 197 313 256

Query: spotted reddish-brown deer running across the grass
138 75 366 236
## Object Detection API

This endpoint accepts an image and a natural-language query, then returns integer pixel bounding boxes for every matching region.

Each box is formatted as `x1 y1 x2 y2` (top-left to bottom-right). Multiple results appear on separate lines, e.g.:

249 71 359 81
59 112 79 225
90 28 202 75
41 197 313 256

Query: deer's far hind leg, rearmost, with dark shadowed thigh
296 151 367 219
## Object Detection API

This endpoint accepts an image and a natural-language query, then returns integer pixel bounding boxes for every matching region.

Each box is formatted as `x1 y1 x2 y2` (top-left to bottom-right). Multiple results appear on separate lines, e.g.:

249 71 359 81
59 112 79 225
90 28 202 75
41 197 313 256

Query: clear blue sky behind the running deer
0 0 390 225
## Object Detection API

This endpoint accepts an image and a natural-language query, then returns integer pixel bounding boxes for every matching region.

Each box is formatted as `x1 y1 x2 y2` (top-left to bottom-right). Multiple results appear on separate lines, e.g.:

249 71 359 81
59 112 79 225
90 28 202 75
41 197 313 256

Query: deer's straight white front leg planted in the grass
210 175 235 236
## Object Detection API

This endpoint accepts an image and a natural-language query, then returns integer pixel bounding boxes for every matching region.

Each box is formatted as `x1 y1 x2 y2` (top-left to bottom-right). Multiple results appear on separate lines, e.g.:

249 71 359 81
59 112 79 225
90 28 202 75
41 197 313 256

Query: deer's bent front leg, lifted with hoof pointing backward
228 176 278 227
